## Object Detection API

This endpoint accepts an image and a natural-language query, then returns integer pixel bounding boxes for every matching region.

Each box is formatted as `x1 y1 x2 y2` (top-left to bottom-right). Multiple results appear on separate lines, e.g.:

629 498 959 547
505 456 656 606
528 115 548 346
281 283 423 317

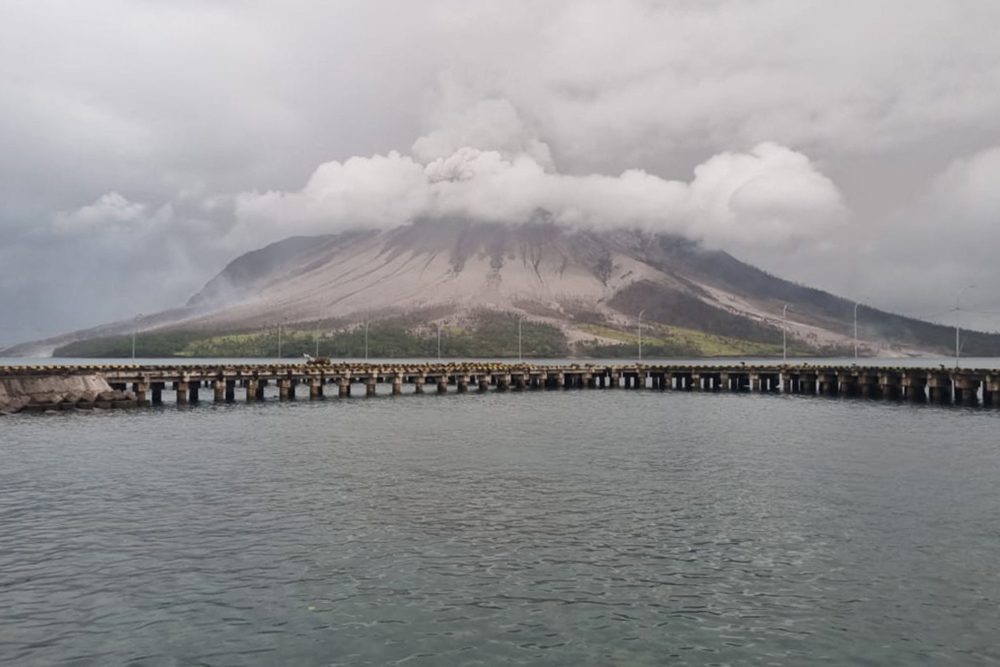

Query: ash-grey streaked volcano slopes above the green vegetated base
7 220 1000 354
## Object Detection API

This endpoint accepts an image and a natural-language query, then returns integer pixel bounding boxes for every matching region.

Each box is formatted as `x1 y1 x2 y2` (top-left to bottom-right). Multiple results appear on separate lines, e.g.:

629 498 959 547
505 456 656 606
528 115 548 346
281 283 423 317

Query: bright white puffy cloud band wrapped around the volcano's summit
233 138 846 256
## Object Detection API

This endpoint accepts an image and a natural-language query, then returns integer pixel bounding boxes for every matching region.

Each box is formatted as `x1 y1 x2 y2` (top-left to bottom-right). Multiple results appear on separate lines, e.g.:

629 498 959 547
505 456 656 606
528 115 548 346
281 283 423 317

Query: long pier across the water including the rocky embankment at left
0 362 1000 412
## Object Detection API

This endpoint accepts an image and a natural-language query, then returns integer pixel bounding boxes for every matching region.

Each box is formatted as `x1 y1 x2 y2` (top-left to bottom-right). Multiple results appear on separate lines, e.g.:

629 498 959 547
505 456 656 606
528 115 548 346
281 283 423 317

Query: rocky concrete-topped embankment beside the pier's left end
0 371 138 415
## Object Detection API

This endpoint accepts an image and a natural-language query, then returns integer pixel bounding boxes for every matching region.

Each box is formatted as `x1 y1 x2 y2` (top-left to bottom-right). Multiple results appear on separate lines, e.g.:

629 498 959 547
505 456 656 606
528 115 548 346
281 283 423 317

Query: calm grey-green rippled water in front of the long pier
0 358 1000 665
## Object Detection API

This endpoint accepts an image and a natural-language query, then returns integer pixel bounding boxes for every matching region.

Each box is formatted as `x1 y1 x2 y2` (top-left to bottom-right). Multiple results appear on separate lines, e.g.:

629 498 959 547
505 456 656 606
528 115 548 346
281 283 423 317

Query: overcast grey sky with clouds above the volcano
0 0 1000 344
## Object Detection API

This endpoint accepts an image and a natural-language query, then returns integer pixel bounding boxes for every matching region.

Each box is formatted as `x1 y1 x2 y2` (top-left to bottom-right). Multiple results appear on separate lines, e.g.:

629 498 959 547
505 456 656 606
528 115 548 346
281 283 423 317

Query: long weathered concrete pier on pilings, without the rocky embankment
11 362 1000 414
